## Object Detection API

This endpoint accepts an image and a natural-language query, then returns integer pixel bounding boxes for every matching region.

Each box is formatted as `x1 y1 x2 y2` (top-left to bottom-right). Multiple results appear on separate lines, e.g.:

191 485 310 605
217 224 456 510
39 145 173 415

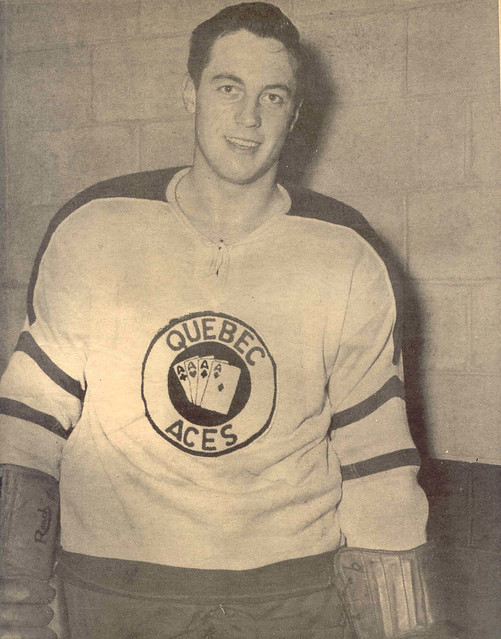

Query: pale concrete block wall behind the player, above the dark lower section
0 0 501 464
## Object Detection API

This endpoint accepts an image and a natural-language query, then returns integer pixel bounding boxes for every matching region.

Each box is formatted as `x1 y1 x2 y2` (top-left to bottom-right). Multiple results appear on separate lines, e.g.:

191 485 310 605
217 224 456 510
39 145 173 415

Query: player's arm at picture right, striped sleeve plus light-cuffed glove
329 247 451 639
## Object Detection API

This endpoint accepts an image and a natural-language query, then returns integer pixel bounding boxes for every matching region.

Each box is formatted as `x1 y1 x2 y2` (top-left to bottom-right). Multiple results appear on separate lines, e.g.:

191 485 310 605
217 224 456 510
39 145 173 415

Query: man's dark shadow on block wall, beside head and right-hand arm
278 44 429 457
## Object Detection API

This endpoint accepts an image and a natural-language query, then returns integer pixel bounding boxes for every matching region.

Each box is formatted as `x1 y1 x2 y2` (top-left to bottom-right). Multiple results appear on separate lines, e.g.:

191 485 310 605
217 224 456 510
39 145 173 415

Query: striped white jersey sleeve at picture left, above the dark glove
0 223 88 478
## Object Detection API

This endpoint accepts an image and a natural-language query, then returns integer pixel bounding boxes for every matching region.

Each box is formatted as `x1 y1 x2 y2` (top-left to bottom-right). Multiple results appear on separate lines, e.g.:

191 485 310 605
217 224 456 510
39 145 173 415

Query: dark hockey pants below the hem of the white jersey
58 553 350 639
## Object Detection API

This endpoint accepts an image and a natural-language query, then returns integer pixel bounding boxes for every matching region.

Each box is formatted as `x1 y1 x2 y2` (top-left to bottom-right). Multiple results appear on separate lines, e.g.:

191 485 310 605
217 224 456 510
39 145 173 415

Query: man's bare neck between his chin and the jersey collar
176 156 280 243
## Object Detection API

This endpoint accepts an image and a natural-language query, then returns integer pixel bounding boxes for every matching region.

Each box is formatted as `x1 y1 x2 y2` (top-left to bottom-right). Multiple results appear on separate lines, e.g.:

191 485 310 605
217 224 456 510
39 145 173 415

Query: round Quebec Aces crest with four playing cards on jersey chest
141 311 277 457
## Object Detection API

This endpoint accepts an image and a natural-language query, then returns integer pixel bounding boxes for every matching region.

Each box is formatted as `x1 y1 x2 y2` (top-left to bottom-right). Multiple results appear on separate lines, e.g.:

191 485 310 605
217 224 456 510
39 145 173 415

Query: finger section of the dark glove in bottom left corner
0 580 57 639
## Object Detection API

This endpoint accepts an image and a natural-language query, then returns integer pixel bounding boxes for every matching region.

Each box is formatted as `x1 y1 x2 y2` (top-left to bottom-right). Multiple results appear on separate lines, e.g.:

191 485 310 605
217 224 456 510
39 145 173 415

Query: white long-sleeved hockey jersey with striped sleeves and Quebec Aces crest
0 172 427 570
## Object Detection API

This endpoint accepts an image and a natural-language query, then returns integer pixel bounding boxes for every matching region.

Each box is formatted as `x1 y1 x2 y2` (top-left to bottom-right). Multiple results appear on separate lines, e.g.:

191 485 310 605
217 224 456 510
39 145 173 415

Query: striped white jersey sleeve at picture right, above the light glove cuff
329 242 428 550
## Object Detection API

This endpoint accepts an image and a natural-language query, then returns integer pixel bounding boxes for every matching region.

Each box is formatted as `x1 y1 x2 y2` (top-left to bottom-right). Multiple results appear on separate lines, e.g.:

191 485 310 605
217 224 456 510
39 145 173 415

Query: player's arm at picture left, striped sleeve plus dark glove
0 218 88 639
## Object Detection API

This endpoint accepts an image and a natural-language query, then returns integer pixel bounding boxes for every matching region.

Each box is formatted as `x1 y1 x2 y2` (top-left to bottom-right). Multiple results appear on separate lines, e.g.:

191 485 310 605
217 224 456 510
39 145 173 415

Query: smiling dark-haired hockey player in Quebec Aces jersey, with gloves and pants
0 3 446 639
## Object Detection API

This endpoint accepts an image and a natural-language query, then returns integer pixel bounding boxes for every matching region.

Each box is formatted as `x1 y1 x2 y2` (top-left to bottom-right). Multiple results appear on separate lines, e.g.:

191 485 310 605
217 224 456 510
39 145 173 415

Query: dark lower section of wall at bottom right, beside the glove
420 459 501 639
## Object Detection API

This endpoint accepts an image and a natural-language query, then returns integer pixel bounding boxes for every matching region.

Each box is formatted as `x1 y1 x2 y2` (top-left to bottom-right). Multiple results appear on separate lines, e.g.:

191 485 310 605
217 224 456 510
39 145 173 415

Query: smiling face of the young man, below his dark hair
185 30 297 184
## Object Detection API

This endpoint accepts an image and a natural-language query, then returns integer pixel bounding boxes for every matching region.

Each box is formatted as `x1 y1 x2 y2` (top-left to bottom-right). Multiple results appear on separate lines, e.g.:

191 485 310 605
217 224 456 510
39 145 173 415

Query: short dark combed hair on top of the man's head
188 2 306 101
